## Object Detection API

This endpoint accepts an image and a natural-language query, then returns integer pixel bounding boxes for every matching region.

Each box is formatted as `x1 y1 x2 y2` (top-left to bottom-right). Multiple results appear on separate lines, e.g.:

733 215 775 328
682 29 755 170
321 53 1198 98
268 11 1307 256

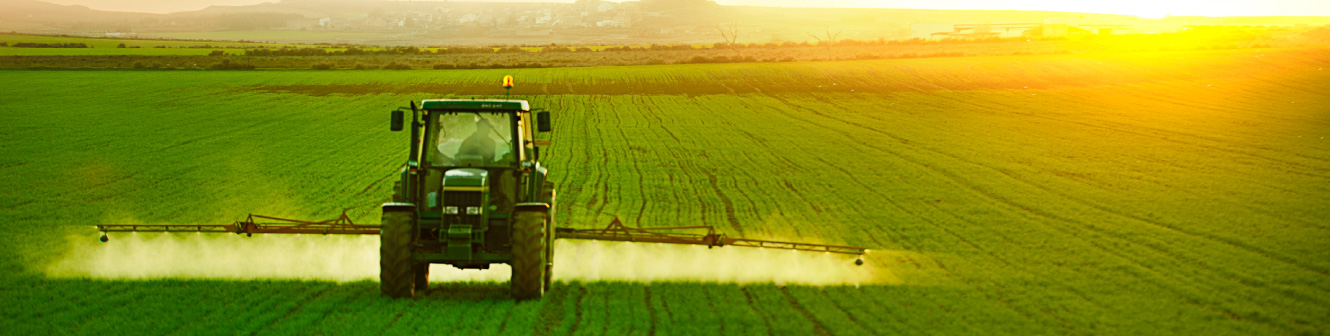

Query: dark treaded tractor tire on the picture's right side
512 211 547 300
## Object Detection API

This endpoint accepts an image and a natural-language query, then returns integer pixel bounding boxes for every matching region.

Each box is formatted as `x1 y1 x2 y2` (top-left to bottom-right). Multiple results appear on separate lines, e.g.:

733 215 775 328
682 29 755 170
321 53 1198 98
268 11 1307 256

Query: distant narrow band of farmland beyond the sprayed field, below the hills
0 27 1330 70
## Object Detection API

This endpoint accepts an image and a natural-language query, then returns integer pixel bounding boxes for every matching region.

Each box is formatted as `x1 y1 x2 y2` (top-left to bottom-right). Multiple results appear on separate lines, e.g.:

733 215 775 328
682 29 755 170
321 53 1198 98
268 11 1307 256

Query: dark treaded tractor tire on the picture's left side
379 211 415 299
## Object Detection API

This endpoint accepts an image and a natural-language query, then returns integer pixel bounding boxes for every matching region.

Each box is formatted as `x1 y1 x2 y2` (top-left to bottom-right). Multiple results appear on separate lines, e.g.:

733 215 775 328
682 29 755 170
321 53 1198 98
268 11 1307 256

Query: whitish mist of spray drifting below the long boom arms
47 232 900 286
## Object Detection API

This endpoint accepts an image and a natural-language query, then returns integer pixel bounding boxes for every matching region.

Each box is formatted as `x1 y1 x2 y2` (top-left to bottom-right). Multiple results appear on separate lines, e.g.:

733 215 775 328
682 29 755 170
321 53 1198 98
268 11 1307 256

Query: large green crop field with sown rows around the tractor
0 48 1330 335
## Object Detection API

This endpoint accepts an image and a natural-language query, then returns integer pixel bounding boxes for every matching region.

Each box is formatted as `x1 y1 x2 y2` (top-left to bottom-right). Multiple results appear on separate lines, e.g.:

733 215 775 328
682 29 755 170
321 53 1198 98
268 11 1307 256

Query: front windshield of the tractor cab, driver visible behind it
426 112 517 167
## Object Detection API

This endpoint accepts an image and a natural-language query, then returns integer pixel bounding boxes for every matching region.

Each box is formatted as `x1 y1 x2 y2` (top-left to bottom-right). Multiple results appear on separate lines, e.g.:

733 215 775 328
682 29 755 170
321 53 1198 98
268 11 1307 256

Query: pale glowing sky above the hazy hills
45 0 1330 17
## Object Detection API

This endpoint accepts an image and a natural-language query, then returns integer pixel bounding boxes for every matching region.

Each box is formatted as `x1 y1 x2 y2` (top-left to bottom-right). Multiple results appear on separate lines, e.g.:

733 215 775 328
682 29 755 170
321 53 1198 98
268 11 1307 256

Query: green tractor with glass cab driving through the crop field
379 100 555 300
